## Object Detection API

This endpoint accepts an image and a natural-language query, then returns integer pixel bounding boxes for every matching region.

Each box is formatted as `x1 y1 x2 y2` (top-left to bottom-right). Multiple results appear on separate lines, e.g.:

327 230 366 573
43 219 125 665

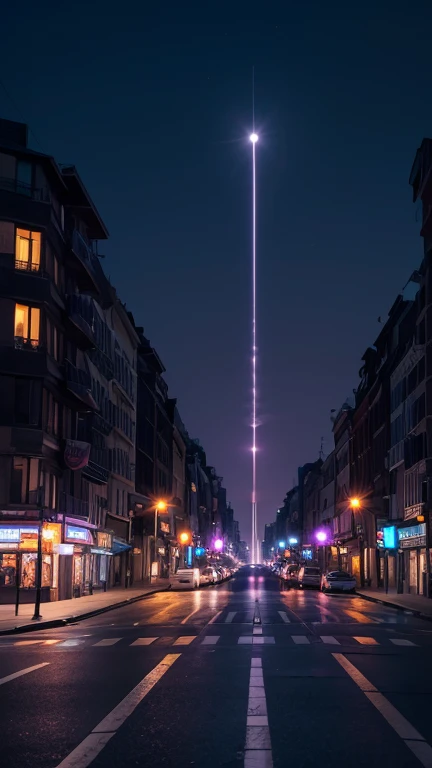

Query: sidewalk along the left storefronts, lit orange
0 579 170 635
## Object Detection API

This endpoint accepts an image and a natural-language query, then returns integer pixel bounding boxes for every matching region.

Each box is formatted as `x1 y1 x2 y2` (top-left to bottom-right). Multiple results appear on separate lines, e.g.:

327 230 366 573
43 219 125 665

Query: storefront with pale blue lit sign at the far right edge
398 523 426 595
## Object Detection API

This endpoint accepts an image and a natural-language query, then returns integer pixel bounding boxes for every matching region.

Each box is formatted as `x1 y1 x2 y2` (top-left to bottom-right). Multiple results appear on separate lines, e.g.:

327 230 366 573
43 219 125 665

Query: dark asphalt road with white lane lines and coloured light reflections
0 568 432 768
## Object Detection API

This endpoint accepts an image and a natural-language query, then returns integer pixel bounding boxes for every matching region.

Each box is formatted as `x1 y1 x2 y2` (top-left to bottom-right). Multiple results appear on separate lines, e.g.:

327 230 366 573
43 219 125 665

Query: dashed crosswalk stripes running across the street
0 627 420 650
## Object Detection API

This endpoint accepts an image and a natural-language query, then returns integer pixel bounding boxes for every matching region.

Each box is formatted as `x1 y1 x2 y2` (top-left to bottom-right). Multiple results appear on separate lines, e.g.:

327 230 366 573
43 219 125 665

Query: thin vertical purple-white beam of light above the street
249 75 260 563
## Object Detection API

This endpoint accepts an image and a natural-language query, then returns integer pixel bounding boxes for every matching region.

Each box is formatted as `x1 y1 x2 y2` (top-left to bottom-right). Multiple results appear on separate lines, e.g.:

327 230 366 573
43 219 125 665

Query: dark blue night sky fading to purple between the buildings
0 6 432 537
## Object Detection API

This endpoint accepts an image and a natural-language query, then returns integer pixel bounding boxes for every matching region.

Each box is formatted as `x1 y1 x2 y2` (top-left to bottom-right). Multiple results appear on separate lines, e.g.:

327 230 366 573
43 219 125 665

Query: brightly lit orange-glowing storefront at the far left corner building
0 523 61 604
